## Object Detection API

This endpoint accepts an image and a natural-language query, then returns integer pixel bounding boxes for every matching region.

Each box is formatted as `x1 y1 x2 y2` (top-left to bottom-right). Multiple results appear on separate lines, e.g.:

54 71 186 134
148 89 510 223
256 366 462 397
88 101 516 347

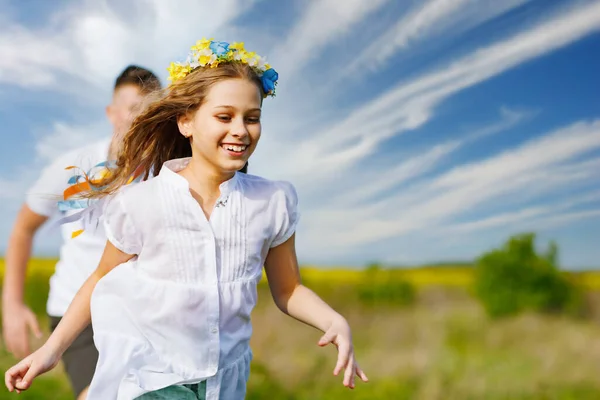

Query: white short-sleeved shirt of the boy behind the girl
25 139 110 317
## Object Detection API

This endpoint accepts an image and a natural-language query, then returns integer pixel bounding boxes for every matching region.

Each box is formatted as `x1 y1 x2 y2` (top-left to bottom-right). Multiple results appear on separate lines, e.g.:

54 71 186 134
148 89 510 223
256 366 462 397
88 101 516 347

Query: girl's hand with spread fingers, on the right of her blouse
319 317 369 389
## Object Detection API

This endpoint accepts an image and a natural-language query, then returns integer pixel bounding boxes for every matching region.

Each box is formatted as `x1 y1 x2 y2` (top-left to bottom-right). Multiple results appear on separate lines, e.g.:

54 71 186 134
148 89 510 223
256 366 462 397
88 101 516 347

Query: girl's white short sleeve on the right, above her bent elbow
270 182 300 248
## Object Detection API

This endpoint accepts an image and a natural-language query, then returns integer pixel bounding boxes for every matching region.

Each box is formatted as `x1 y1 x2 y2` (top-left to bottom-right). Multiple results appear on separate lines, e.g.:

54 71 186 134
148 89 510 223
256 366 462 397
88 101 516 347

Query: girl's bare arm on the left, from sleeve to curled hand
4 241 134 392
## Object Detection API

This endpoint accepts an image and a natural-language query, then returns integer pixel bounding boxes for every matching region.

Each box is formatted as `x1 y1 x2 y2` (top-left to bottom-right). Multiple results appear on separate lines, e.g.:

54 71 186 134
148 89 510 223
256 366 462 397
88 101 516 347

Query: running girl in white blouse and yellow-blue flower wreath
5 40 367 400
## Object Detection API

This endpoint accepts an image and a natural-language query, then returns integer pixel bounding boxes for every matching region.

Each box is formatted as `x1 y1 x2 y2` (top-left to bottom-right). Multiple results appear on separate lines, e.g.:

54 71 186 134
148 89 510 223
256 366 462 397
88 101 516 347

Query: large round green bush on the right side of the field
474 233 581 317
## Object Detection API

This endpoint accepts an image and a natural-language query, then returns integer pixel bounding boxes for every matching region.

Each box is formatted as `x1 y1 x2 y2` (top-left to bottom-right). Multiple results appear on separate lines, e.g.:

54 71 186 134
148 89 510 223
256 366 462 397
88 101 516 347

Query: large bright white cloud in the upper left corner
0 0 253 93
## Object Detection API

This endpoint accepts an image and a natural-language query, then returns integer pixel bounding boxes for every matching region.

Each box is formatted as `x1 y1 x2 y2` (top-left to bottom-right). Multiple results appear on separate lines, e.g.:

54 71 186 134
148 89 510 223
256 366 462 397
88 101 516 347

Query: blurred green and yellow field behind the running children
0 260 600 400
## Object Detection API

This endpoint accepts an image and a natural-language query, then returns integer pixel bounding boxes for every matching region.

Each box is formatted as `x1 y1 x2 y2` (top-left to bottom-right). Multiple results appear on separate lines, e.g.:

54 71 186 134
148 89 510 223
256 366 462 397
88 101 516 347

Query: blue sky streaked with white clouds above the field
0 0 600 269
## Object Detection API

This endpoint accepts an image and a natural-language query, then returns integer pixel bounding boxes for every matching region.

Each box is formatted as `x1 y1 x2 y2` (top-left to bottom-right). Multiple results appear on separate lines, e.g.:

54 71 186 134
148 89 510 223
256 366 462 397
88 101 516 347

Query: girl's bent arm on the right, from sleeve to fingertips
265 235 368 388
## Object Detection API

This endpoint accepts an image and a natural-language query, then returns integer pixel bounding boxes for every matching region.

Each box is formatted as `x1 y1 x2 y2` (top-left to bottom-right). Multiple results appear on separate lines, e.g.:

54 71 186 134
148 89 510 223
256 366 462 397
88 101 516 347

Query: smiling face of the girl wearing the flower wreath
178 78 262 175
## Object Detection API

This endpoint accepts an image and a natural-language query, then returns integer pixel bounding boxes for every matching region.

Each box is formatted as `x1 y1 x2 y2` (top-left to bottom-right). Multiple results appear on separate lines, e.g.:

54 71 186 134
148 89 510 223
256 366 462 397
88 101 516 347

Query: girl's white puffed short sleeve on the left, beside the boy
103 192 142 254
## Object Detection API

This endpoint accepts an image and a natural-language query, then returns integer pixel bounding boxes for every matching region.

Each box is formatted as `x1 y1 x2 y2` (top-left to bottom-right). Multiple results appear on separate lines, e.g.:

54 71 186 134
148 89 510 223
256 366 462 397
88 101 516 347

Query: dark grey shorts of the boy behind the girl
50 316 98 397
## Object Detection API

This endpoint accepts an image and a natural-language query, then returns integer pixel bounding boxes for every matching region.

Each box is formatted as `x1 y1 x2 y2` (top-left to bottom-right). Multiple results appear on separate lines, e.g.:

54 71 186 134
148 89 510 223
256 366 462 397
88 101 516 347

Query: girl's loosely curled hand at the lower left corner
4 345 60 393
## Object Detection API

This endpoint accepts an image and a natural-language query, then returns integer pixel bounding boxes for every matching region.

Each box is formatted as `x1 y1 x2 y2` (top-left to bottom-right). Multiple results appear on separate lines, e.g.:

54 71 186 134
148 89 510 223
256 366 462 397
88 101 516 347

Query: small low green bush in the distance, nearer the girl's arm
358 264 416 306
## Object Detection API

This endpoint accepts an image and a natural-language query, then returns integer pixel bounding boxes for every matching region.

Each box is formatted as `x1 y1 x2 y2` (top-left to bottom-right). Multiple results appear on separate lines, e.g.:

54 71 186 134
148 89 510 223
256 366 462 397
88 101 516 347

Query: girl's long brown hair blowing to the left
82 62 264 198
